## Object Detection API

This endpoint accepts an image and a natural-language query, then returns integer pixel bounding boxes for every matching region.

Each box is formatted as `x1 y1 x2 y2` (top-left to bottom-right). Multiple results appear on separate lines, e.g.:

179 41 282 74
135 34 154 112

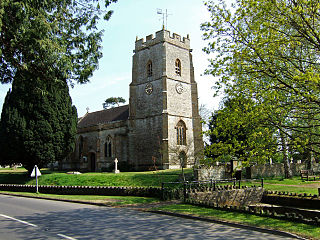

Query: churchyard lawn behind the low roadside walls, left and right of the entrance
0 168 320 194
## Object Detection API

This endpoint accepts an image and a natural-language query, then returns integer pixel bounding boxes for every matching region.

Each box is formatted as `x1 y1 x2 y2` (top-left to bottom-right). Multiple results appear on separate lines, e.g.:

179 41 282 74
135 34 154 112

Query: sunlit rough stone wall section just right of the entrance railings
188 187 263 207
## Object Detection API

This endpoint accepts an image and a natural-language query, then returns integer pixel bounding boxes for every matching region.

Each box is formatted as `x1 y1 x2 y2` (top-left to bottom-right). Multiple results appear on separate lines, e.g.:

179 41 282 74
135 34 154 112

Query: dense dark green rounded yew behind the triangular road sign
0 69 77 172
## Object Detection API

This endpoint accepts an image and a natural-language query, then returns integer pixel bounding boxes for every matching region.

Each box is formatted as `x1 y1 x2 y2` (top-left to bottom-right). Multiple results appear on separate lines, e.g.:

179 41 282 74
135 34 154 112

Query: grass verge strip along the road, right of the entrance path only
154 204 320 239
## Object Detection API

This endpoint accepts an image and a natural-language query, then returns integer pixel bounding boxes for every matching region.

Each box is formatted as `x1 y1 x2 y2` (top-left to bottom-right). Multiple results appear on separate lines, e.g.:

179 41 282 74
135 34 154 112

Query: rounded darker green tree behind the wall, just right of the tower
203 95 277 166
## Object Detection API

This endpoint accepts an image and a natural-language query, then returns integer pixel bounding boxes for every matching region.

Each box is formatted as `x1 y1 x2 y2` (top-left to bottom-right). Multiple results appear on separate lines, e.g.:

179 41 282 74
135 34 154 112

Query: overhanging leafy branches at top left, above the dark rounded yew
0 0 117 84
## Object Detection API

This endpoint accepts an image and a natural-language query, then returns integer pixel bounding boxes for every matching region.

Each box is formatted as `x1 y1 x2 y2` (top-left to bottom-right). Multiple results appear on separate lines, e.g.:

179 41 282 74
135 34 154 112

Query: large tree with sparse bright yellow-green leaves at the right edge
202 0 320 176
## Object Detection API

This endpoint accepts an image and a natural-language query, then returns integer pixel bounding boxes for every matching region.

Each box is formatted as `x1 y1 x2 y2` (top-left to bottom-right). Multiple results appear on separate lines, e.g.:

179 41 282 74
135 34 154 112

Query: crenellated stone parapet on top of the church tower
135 29 190 52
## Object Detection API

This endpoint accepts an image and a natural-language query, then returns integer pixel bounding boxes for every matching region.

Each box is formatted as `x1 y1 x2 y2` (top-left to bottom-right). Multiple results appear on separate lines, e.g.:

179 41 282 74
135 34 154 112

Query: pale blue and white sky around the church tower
0 0 219 117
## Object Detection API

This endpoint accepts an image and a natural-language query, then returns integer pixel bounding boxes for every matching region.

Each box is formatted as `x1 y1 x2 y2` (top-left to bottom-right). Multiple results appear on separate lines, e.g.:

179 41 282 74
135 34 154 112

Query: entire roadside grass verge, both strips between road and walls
0 188 320 239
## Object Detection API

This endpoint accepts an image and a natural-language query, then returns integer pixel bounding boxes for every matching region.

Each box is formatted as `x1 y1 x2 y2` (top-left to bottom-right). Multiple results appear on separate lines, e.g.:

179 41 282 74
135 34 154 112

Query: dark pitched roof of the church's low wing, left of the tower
78 105 129 128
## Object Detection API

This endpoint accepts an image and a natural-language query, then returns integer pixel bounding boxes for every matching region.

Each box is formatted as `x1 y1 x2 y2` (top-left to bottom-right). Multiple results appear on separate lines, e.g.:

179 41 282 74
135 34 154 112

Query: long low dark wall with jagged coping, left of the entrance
0 184 162 198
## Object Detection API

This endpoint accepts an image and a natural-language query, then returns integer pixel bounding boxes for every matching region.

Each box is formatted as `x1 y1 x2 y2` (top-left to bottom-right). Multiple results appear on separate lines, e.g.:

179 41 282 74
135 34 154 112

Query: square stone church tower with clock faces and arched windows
129 30 203 169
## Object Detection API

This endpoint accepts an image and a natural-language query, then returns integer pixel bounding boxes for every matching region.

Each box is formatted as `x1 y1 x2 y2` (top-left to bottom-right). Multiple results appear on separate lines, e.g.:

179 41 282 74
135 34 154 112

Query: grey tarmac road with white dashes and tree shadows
0 194 292 240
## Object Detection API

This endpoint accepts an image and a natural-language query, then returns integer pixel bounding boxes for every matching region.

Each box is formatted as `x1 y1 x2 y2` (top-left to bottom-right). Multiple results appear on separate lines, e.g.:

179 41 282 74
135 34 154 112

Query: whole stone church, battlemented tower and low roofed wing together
62 29 203 172
